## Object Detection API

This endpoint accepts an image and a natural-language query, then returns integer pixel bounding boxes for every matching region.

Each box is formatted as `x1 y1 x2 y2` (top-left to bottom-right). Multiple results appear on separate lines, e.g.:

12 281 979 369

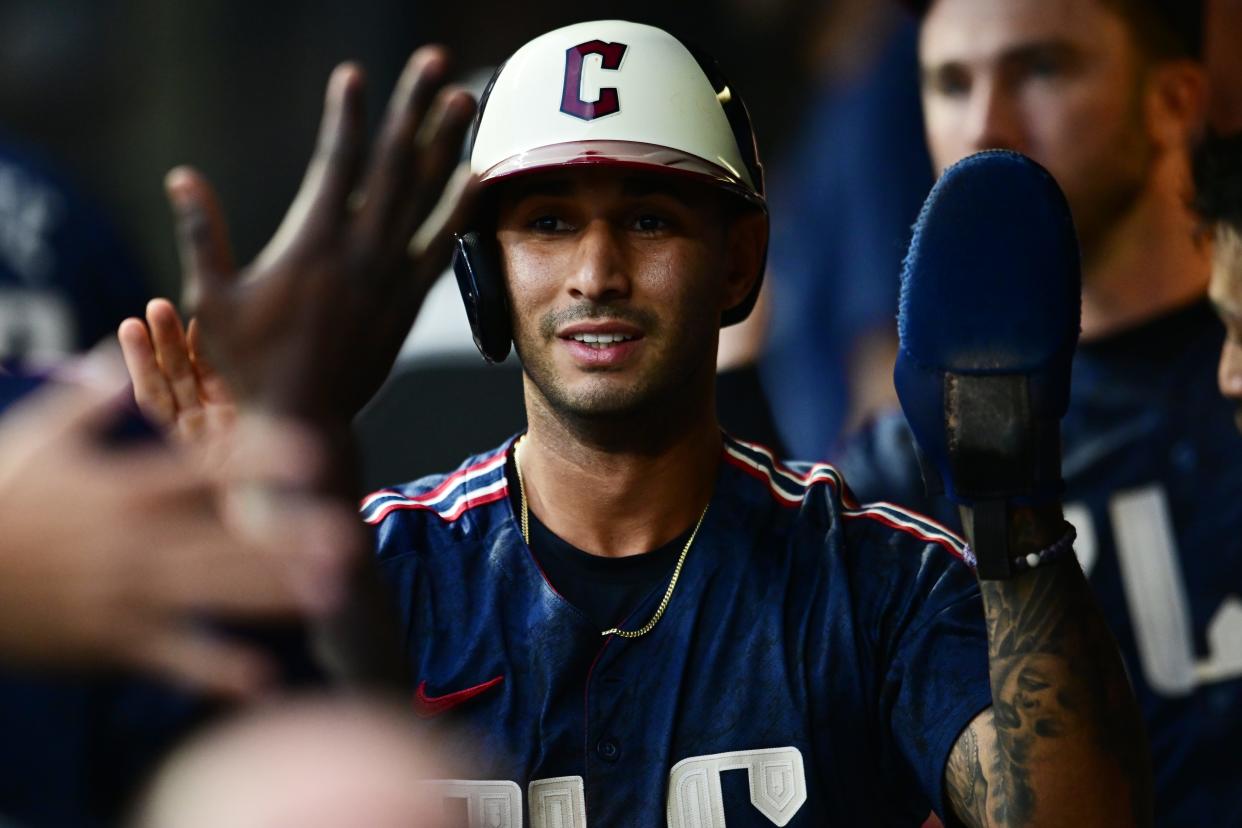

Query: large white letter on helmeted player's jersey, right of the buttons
668 747 806 828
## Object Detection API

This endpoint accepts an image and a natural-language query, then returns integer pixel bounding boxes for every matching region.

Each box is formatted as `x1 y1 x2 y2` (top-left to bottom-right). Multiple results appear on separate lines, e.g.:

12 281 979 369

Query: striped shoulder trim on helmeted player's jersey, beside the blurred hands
361 442 509 526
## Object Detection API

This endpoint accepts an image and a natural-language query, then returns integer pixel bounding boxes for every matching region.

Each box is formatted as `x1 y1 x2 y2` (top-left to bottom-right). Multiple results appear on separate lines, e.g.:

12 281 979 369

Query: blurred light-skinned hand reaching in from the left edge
0 386 364 695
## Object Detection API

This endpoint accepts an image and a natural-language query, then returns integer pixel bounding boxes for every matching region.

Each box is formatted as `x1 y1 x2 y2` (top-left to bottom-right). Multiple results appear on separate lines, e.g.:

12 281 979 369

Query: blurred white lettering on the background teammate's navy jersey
1066 485 1242 696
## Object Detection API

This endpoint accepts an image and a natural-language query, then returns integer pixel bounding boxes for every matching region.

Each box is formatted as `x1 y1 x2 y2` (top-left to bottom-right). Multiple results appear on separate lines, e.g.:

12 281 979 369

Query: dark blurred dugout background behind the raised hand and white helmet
0 0 904 485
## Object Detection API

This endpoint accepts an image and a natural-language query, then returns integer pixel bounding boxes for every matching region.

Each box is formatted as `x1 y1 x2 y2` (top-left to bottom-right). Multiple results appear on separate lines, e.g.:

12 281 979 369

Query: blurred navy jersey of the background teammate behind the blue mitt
841 302 1242 826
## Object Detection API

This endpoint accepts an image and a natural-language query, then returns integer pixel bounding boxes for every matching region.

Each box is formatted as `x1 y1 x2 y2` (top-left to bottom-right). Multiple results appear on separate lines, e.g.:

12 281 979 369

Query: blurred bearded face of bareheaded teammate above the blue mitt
919 0 1153 254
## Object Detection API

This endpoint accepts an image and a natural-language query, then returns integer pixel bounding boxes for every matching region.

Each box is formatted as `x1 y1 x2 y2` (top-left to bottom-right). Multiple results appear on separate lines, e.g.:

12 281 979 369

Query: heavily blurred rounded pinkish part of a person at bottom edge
132 695 462 828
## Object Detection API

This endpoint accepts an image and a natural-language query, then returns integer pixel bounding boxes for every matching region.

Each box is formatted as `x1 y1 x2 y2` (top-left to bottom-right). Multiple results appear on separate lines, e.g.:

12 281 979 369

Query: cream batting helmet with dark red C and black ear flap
453 20 768 361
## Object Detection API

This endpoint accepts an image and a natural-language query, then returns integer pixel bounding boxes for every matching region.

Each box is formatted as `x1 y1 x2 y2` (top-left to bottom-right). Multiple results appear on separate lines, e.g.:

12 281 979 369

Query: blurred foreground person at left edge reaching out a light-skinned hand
0 358 360 828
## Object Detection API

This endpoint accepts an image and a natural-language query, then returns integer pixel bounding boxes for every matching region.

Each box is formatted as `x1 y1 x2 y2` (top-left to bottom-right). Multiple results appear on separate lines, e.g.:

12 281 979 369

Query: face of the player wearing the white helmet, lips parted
497 168 738 417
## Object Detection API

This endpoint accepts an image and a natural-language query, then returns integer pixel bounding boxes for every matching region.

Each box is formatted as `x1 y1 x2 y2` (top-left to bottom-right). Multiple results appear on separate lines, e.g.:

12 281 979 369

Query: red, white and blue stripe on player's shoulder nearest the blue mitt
724 436 975 566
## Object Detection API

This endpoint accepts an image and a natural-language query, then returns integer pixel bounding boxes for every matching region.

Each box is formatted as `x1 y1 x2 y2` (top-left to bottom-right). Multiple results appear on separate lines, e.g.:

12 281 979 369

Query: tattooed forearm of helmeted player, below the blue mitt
946 509 1151 826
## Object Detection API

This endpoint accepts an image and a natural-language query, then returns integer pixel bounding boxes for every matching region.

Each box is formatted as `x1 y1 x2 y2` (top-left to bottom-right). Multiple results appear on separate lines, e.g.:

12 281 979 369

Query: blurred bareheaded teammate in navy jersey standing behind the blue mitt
842 0 1242 826
